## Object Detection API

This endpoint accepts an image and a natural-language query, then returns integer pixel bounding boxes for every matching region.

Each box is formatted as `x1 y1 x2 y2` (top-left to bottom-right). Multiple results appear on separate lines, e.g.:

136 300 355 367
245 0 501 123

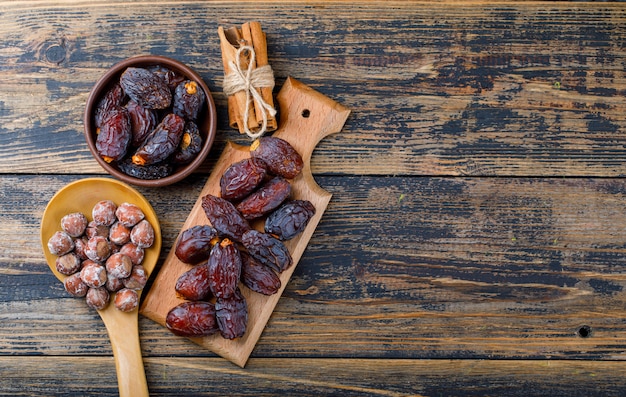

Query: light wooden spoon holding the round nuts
41 178 161 397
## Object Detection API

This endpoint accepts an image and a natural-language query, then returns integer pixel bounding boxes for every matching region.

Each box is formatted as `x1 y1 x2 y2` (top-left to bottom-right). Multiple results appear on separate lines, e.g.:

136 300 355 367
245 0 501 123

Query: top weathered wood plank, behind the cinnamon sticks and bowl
0 1 626 177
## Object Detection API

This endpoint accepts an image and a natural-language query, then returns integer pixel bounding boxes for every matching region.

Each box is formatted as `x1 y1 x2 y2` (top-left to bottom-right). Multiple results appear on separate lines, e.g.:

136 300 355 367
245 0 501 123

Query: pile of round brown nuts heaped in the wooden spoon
48 200 155 312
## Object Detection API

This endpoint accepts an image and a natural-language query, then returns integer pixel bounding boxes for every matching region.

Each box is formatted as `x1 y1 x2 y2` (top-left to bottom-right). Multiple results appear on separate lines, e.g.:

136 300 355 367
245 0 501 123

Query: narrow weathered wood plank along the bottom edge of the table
0 357 626 397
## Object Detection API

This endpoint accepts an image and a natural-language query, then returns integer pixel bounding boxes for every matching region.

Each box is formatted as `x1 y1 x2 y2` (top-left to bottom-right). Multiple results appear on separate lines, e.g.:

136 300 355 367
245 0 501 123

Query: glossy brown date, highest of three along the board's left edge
174 225 217 265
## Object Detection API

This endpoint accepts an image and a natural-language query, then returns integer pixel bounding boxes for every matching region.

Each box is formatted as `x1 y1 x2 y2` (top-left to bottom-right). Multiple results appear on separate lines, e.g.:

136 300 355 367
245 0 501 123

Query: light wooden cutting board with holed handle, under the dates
140 78 350 367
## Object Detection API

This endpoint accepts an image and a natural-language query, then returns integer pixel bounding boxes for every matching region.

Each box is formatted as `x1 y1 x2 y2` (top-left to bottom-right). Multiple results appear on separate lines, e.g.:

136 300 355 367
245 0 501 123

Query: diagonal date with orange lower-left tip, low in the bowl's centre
132 113 185 165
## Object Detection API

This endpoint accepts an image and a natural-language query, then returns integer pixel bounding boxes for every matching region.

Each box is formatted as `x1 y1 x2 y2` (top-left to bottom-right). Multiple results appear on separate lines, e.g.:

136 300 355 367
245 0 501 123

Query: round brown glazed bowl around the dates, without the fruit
83 55 217 187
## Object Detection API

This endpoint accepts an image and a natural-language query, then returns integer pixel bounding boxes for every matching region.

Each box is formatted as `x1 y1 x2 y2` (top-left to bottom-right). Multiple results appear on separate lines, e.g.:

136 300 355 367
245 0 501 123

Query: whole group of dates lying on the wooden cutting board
166 137 315 339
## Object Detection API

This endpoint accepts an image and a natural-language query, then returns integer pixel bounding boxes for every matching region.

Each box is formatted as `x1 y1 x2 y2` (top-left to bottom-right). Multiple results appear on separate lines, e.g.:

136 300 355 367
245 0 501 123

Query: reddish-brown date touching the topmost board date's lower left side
220 158 267 201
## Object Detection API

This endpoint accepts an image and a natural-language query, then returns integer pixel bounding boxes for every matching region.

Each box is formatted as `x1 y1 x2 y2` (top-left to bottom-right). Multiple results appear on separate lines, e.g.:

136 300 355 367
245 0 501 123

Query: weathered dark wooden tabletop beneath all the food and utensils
0 0 626 396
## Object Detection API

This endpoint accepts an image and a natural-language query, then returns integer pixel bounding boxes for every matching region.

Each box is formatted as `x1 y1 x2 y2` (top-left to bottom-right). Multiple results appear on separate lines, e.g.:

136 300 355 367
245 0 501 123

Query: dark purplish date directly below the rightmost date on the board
241 229 293 273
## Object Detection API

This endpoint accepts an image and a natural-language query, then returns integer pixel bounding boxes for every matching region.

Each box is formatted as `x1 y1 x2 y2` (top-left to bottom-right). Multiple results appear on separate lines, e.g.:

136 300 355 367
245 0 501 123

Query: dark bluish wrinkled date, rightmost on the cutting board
265 200 315 241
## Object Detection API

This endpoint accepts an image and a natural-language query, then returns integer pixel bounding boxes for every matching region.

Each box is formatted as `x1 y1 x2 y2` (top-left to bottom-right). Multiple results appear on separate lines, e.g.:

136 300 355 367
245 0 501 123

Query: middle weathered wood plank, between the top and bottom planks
0 176 626 360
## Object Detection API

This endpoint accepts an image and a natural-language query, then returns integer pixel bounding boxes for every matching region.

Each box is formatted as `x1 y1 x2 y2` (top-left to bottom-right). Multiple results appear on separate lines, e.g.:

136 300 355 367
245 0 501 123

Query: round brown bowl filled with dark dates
84 55 216 187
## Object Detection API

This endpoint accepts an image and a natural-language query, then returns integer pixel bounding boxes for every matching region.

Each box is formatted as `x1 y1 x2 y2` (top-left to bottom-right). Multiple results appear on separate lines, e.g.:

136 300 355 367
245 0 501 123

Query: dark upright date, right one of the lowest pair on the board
215 288 248 339
